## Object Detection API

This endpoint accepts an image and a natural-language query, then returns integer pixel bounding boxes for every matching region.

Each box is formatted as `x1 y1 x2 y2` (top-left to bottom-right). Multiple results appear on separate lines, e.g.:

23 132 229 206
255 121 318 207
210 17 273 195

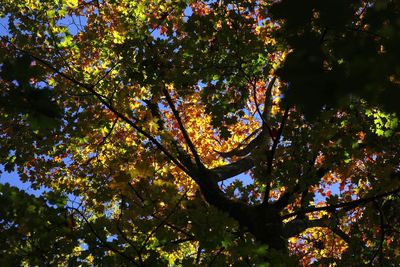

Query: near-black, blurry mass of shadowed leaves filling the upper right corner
271 0 400 116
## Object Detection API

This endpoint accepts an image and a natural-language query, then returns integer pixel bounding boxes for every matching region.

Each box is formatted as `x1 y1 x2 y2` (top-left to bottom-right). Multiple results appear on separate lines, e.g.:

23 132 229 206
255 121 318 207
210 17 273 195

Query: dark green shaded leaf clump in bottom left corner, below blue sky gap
0 184 79 266
